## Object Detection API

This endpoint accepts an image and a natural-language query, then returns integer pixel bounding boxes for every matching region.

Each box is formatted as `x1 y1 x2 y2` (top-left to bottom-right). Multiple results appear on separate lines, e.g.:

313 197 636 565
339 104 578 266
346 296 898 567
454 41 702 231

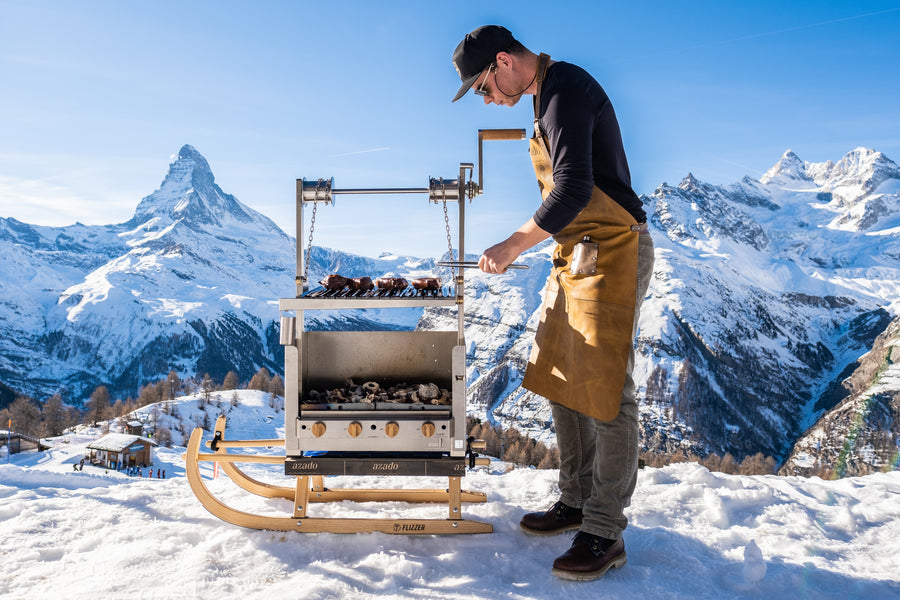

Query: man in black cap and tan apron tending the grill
453 25 653 580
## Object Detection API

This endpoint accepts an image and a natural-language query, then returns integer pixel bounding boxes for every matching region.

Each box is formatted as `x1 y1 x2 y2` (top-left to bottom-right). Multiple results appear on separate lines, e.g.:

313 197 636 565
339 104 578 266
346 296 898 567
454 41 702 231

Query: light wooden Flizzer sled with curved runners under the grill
185 415 493 535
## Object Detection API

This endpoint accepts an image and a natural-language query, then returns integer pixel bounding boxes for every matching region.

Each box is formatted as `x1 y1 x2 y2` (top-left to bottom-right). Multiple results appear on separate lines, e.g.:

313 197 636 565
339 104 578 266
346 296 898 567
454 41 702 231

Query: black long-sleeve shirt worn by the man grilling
534 62 647 234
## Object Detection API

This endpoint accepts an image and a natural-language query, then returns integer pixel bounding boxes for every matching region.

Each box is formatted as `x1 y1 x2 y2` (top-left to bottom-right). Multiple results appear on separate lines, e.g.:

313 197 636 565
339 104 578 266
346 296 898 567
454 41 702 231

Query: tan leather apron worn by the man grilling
522 54 640 421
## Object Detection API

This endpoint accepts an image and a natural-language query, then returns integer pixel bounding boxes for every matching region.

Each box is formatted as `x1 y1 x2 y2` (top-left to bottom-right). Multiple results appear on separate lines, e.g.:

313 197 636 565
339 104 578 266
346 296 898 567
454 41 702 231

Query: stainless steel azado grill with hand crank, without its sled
279 130 525 475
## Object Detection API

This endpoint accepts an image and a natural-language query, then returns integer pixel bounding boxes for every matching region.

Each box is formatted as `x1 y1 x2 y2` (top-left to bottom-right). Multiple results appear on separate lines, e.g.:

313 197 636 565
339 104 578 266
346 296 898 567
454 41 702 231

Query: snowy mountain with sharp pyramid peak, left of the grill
0 145 430 403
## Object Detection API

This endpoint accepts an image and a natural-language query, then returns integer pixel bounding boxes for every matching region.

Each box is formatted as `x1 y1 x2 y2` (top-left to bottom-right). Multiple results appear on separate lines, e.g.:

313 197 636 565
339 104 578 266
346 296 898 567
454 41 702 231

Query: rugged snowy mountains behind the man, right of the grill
444 148 900 465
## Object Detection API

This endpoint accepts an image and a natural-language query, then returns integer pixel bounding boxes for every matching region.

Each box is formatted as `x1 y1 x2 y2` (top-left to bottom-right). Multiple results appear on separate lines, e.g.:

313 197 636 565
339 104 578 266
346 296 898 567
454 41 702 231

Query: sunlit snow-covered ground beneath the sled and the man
0 391 900 600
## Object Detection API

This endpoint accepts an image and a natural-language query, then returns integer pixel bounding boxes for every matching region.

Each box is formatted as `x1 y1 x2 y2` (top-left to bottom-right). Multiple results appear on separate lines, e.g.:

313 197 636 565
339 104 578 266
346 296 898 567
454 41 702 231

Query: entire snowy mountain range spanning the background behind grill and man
0 146 900 474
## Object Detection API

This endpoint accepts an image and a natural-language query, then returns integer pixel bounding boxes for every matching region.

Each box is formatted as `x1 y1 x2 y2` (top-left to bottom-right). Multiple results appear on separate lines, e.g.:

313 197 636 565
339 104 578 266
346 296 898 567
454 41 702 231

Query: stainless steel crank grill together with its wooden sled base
185 129 525 535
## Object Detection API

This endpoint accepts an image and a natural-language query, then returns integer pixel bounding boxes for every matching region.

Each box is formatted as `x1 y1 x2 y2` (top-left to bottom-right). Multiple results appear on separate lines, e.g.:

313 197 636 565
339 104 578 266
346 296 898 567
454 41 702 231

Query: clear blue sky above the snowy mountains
0 0 900 256
